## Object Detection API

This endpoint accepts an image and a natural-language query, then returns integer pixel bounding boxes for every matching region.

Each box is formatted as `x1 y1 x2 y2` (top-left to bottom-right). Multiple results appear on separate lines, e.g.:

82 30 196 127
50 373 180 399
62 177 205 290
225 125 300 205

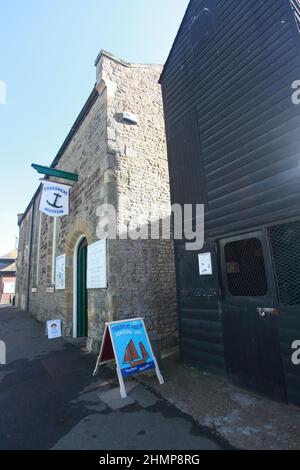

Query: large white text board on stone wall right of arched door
87 239 107 289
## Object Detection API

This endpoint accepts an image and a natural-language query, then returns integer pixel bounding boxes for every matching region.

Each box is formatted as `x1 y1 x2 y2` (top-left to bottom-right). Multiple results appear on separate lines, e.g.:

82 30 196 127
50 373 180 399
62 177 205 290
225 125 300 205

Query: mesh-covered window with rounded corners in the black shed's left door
224 238 268 297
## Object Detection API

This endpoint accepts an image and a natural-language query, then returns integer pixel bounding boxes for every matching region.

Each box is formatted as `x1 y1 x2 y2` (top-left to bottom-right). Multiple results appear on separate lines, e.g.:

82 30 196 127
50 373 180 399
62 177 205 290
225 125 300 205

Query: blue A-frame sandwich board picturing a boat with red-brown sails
93 318 164 398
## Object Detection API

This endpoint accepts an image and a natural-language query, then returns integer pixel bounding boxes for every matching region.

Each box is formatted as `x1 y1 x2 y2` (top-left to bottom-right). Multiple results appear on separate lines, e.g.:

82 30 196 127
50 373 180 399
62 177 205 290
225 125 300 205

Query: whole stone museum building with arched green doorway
16 51 177 350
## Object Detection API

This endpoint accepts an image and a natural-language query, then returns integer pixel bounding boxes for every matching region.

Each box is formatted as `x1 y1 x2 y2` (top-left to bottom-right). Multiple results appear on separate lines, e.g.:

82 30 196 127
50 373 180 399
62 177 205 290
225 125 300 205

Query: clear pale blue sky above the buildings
0 0 188 255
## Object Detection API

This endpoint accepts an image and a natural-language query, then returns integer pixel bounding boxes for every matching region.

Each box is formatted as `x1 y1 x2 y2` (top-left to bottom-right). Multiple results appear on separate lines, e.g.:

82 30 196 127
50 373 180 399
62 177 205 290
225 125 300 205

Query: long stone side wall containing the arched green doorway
26 90 106 346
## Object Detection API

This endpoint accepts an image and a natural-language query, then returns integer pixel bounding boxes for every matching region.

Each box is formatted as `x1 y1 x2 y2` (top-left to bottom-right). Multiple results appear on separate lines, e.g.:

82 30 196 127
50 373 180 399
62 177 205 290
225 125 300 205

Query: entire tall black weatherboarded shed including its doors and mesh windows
161 0 300 404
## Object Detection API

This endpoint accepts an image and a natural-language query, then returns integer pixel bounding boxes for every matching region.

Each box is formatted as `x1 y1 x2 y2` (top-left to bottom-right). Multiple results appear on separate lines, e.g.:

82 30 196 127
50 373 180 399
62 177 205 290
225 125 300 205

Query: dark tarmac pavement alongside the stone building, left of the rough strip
0 307 228 450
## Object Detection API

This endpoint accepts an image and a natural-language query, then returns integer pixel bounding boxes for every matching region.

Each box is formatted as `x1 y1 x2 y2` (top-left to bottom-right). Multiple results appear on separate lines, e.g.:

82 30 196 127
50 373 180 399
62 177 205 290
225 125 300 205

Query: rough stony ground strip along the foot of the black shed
139 357 300 450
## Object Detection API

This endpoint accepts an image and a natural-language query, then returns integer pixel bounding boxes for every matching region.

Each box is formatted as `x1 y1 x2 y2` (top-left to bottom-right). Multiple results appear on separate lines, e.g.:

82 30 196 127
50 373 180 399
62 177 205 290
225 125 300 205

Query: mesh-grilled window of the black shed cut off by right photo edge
269 221 300 306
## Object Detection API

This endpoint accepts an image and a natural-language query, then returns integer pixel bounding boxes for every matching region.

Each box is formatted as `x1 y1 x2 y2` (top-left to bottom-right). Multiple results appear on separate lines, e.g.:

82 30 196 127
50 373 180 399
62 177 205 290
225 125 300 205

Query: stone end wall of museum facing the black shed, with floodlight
97 56 177 346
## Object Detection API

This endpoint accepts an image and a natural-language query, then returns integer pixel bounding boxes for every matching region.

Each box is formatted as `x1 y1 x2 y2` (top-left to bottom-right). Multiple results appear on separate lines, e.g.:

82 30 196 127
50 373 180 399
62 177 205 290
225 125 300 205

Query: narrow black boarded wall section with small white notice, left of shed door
176 241 225 375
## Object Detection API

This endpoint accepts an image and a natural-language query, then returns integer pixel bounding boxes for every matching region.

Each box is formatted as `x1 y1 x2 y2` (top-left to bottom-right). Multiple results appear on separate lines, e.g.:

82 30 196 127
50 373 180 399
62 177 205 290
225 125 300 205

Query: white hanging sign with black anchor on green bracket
40 181 70 217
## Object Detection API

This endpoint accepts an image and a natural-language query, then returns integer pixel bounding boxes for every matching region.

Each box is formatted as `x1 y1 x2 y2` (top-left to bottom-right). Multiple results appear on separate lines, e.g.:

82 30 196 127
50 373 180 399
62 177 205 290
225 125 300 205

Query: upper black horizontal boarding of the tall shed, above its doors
161 0 300 235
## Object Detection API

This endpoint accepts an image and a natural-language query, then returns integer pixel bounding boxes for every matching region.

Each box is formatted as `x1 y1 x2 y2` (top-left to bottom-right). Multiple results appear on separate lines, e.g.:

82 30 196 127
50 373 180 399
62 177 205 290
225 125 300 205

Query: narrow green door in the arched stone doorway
77 238 88 338
